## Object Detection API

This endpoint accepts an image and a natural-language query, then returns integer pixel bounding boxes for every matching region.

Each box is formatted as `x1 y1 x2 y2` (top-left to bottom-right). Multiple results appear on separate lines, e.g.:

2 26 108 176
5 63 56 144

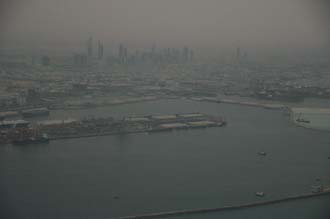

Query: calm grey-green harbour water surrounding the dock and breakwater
0 100 330 218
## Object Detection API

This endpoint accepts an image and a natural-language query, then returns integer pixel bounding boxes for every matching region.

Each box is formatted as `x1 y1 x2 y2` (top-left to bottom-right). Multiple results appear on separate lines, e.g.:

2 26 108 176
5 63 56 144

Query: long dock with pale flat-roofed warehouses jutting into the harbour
0 112 227 144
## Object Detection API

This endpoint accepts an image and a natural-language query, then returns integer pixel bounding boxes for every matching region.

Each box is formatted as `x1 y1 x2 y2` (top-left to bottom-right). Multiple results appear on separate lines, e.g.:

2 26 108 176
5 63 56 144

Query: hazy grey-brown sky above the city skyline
0 0 330 47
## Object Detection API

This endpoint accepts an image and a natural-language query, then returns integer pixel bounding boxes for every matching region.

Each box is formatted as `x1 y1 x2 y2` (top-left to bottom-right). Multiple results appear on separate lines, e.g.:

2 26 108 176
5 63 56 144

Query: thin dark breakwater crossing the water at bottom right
115 188 330 219
